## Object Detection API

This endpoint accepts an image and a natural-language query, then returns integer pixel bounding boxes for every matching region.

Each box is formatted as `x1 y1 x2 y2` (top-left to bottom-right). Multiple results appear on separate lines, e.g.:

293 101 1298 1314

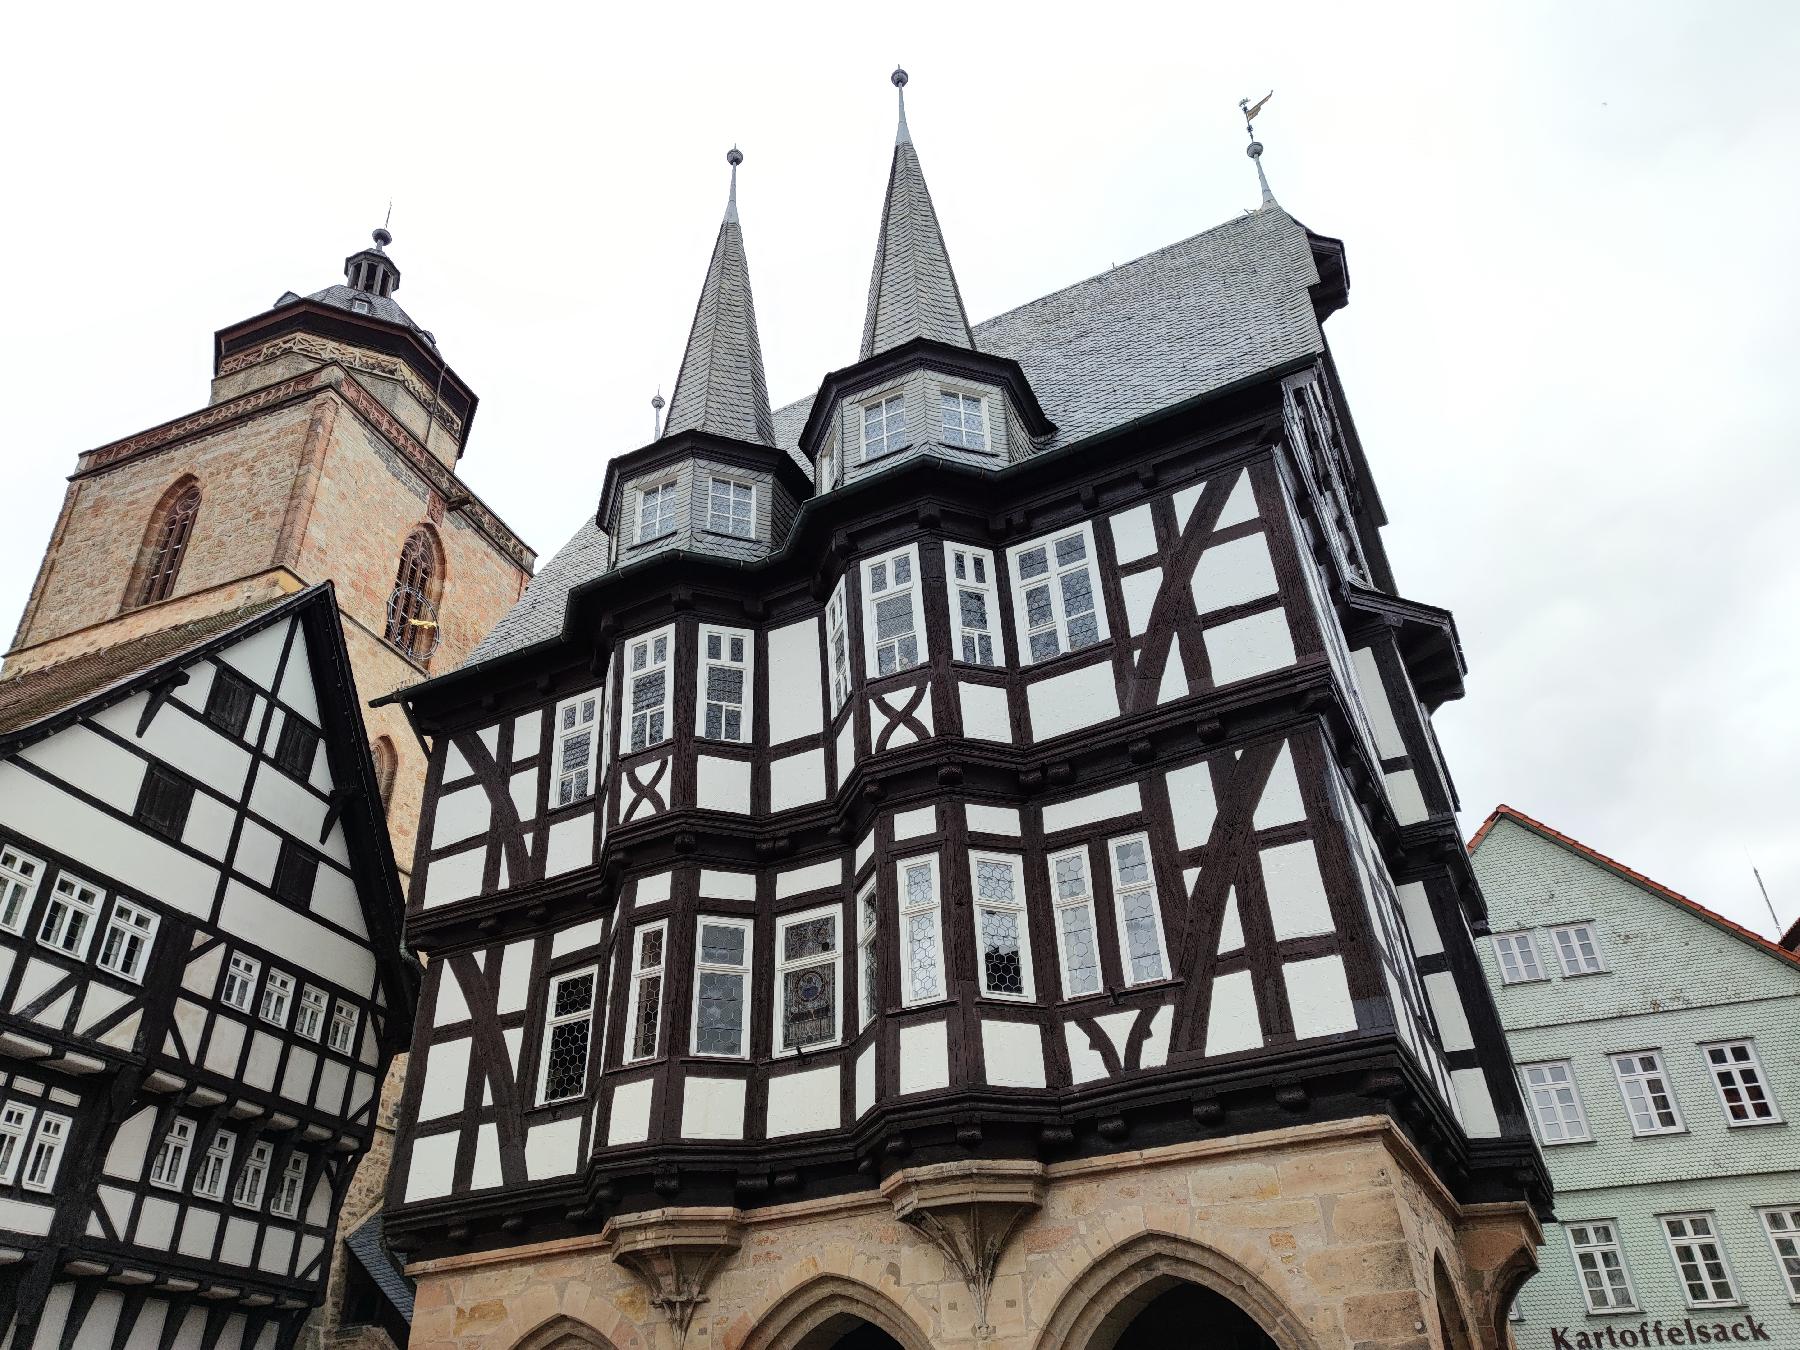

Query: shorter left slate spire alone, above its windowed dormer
662 146 776 445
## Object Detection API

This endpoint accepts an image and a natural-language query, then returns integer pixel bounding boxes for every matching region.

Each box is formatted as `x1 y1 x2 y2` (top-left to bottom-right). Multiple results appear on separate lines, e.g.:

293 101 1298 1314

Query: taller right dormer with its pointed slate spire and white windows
801 70 1055 491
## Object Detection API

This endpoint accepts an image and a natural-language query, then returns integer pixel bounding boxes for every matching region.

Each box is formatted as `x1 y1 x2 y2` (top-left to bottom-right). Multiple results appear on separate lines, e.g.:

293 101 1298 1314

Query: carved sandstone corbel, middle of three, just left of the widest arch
882 1157 1044 1337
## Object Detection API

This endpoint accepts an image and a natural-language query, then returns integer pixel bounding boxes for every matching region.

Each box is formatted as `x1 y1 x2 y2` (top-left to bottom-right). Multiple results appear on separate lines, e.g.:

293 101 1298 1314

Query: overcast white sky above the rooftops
0 0 1800 931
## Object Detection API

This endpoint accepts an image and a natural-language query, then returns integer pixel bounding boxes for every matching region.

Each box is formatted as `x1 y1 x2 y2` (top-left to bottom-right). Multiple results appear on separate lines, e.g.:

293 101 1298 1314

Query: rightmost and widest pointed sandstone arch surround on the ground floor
1035 1231 1319 1350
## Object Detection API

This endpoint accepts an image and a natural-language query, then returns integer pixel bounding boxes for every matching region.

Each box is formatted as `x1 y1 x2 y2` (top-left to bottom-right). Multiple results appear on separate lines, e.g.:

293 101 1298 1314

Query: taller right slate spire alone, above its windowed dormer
862 70 976 360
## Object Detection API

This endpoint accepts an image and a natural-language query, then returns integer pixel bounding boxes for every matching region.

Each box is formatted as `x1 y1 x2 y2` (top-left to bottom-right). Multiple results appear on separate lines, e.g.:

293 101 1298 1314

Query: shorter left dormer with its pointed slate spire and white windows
596 146 810 565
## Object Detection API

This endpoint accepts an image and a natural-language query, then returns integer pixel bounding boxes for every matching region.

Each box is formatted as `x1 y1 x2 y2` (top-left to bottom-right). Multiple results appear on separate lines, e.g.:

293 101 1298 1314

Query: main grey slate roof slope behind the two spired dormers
470 203 1325 662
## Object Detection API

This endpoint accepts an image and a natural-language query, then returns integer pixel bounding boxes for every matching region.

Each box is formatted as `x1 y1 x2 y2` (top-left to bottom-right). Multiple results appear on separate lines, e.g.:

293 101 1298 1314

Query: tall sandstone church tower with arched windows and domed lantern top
0 230 533 889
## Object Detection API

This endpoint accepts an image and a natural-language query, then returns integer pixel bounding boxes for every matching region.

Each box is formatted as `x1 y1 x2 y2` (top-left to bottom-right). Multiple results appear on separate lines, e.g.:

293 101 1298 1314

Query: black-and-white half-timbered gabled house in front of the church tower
0 585 418 1350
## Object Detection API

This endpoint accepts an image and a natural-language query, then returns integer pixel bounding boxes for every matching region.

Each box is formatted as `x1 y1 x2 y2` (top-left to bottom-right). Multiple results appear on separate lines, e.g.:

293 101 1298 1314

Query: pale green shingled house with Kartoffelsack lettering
1472 806 1800 1350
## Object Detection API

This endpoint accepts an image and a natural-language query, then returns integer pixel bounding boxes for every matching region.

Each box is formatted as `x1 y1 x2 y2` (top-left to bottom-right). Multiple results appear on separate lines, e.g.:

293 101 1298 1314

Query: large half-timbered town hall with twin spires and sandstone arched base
387 72 1548 1350
